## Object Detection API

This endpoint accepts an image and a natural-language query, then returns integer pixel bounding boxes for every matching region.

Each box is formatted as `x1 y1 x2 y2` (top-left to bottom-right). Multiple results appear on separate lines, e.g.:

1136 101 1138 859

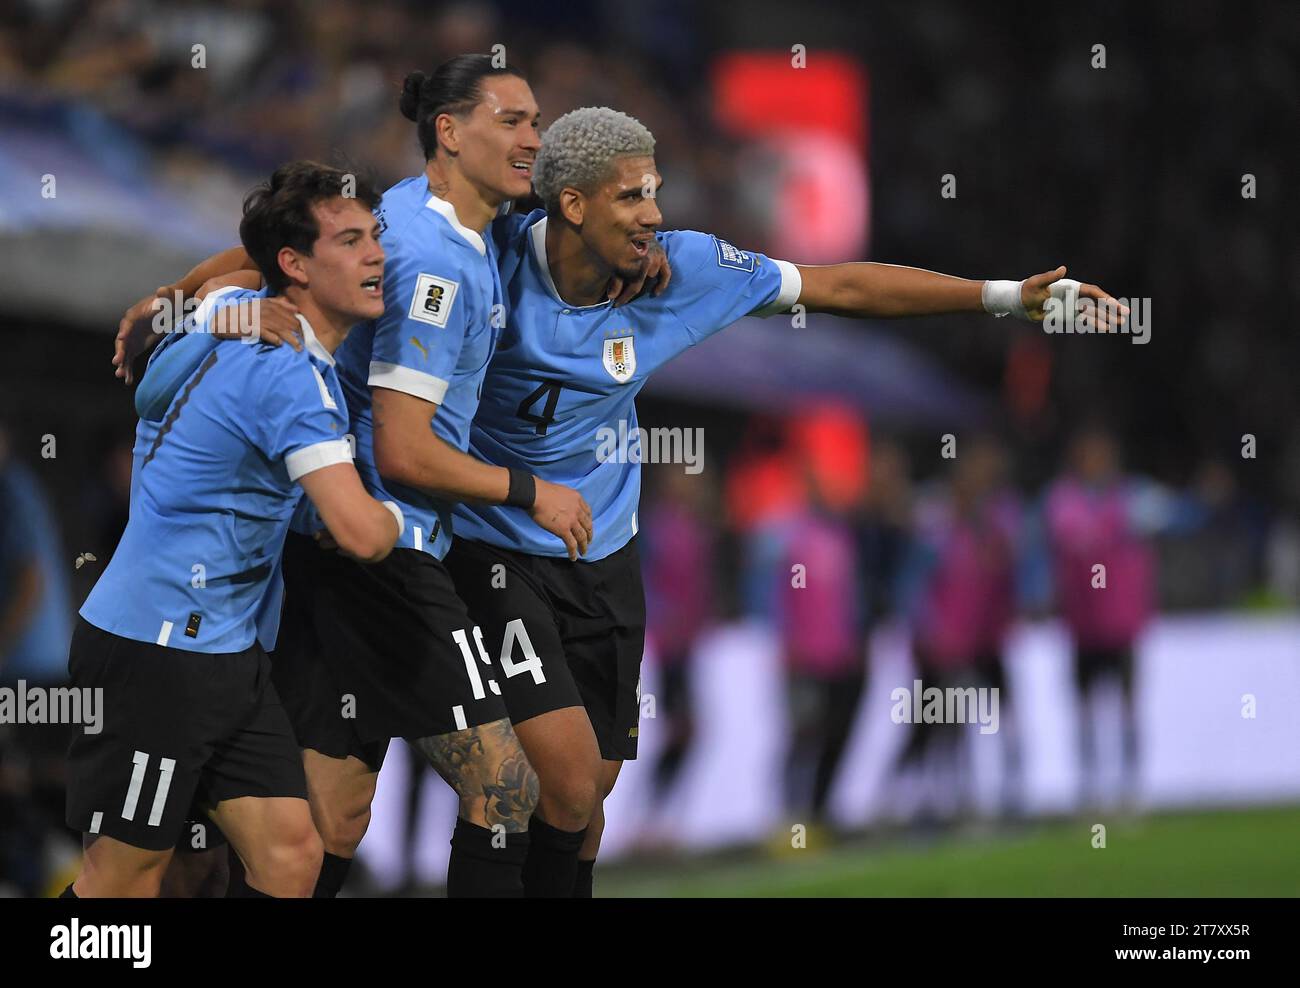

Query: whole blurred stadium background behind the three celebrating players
0 0 1300 896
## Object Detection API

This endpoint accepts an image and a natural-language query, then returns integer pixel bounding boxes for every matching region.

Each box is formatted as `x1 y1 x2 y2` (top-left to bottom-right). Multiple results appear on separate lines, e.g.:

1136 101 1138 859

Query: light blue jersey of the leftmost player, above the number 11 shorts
81 305 351 653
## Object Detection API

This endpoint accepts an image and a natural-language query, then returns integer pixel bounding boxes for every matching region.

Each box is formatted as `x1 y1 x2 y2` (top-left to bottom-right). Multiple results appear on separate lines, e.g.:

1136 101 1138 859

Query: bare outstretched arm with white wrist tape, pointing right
796 261 1128 330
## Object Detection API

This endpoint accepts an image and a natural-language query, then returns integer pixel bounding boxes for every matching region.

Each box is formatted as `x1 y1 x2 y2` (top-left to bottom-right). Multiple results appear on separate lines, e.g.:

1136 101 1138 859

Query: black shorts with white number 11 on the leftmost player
66 619 307 850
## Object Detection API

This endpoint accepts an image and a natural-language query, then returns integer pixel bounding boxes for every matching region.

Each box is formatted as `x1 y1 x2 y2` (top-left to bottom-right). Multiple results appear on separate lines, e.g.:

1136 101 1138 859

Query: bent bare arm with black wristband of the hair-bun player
371 387 593 559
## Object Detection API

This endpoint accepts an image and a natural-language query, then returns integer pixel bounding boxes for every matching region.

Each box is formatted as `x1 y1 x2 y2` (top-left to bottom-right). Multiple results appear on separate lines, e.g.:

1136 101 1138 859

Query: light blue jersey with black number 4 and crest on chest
456 211 801 562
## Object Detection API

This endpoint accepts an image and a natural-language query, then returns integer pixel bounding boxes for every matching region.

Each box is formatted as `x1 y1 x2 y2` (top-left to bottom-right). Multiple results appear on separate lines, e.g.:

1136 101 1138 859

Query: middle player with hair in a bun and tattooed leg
131 56 624 896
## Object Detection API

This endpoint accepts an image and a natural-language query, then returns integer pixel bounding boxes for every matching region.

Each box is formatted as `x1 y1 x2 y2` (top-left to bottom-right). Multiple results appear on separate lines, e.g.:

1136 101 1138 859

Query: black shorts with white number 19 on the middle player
272 532 506 770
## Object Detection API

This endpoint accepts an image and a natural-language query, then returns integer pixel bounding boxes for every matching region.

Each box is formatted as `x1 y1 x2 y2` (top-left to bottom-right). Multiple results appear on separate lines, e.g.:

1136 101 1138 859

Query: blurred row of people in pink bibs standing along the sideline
641 407 1300 822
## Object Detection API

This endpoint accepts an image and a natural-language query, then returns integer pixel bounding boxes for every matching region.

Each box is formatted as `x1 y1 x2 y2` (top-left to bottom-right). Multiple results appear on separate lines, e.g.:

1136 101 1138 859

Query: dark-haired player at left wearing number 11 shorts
65 163 403 897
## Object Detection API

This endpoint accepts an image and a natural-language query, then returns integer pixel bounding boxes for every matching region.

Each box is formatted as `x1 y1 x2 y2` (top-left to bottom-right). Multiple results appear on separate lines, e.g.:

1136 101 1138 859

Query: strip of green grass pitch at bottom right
597 807 1300 897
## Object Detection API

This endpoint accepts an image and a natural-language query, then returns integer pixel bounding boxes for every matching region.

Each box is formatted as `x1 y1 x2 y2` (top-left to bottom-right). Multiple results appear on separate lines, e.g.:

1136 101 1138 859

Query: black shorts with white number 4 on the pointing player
447 538 646 761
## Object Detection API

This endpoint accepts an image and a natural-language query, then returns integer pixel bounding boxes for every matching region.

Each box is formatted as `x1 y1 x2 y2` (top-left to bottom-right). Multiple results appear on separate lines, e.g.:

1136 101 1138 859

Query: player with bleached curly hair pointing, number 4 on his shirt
447 107 1119 897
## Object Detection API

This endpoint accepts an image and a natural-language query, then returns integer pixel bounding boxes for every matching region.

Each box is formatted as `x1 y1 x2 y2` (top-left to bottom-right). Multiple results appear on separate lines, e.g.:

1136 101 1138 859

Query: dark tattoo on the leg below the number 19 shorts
415 719 540 833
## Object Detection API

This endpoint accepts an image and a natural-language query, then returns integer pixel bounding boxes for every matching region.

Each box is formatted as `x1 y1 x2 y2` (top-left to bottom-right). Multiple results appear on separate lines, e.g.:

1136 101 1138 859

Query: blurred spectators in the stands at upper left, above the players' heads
0 0 744 235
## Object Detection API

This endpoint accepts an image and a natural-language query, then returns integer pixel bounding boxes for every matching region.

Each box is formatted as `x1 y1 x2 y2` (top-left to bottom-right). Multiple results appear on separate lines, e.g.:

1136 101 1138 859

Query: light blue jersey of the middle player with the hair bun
322 176 504 559
